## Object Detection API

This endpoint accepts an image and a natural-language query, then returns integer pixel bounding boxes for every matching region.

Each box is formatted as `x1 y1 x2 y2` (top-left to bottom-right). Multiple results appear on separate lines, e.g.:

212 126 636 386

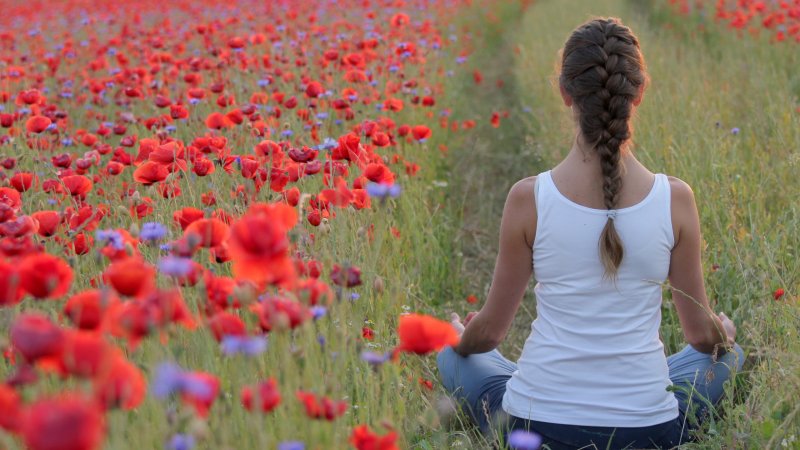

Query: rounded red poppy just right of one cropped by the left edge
18 253 73 299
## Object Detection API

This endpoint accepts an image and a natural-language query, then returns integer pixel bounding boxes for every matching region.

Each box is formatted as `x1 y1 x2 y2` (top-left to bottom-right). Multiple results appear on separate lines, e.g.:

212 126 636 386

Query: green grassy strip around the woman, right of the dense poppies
443 0 800 448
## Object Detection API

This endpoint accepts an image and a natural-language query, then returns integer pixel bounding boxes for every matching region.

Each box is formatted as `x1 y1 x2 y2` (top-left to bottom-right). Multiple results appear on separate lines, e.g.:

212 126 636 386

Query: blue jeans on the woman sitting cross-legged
436 344 744 450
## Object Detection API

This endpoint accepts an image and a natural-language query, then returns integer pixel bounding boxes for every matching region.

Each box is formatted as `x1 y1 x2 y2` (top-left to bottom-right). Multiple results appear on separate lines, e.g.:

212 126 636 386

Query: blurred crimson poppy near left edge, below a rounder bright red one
9 313 64 362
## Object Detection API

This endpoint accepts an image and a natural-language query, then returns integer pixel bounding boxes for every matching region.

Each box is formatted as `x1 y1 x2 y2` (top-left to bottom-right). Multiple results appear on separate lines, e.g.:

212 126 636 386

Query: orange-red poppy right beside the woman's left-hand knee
397 314 460 355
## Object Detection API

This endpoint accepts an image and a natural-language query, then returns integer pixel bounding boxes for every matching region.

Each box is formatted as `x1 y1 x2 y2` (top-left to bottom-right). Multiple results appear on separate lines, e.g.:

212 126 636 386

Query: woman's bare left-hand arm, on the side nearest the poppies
454 177 536 356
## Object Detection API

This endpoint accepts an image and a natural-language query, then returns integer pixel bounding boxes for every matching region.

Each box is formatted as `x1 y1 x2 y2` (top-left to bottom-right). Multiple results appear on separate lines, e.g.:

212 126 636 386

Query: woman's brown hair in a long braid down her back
559 18 647 278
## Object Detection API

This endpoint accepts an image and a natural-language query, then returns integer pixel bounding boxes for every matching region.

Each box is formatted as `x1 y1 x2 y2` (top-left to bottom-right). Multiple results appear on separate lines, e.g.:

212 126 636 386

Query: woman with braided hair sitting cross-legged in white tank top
438 15 744 449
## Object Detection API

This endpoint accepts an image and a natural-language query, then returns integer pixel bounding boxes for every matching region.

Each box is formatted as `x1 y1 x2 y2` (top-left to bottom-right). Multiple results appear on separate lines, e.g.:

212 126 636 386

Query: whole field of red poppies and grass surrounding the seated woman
0 0 800 450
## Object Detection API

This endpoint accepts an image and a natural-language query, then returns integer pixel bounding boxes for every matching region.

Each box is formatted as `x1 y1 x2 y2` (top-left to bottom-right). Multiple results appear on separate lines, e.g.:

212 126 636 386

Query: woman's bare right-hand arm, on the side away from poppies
669 178 733 353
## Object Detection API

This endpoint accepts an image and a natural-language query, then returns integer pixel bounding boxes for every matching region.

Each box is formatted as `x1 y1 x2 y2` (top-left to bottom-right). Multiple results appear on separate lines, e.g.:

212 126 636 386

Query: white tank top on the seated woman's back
503 171 678 427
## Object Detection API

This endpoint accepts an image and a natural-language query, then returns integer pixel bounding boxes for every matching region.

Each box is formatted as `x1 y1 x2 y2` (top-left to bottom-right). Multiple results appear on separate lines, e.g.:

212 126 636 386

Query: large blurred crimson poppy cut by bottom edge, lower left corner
20 393 104 450
